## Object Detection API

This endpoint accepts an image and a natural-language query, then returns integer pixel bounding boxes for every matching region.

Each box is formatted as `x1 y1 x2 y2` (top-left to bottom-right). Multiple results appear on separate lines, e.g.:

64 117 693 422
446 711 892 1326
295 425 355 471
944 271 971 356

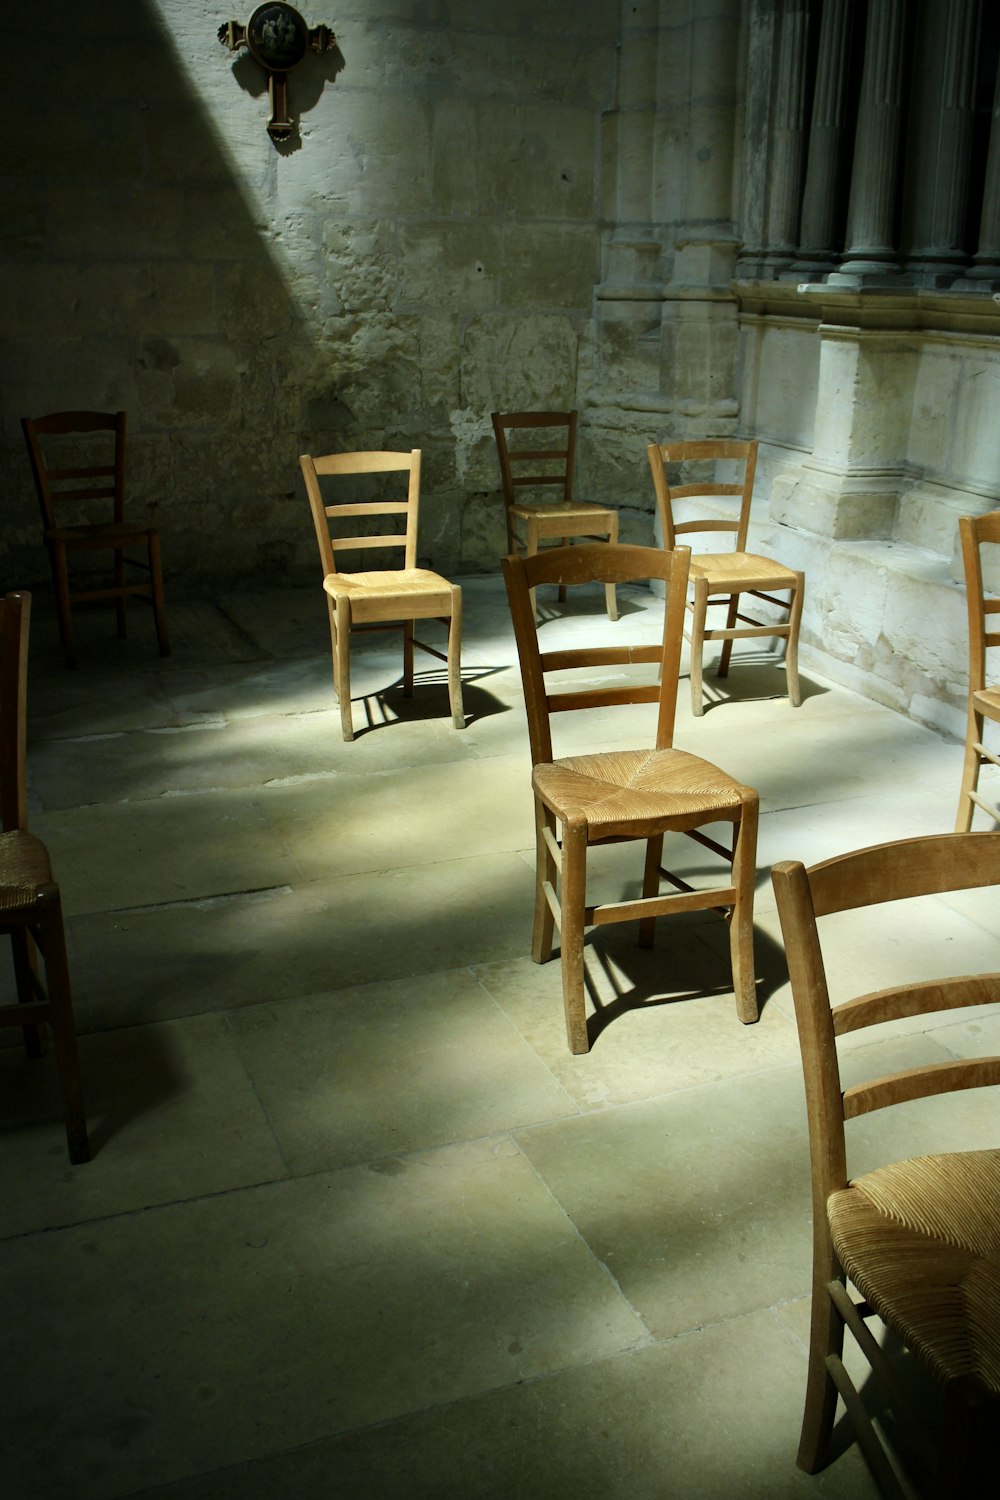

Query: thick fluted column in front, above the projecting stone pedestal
831 0 907 285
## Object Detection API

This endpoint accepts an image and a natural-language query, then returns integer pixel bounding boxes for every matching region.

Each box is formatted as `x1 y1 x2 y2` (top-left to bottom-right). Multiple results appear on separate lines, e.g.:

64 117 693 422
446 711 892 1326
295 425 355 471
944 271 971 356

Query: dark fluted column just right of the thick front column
910 0 981 284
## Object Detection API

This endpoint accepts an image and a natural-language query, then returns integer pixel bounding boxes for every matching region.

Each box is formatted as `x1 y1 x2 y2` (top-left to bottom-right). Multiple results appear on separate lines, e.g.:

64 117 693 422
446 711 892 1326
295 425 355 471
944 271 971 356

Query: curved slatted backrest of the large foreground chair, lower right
772 833 1000 1223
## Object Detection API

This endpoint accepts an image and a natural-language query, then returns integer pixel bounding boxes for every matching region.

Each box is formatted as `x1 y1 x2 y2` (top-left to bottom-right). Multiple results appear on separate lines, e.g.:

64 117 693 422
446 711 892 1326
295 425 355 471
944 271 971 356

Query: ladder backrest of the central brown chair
501 542 691 765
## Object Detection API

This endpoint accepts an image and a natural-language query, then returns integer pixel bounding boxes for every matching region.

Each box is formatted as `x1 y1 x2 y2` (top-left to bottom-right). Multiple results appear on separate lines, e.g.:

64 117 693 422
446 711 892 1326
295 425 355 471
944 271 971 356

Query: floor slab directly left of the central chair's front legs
229 971 576 1173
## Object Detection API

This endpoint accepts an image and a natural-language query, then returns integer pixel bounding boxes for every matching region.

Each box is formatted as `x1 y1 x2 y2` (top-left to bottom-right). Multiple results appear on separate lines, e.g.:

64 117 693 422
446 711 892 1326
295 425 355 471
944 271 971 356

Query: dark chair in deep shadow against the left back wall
21 411 169 666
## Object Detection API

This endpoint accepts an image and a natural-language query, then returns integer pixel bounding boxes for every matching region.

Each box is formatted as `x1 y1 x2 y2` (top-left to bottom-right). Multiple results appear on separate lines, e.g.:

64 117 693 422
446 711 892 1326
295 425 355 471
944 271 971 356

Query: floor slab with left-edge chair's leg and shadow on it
0 1016 286 1236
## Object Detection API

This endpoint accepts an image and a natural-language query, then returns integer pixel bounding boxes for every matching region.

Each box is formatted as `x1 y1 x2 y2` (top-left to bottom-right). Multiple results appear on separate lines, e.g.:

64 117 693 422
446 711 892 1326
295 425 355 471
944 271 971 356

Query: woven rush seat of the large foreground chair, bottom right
826 1151 1000 1395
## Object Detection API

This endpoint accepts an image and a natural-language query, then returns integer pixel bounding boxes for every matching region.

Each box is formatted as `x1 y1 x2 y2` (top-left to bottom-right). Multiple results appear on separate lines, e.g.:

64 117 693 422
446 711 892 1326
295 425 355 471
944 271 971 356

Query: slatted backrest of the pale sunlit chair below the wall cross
298 449 420 578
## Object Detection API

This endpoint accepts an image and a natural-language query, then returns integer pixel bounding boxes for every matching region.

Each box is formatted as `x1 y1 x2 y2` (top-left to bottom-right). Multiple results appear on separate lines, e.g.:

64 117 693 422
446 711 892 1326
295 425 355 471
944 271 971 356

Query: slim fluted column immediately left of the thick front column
795 0 855 272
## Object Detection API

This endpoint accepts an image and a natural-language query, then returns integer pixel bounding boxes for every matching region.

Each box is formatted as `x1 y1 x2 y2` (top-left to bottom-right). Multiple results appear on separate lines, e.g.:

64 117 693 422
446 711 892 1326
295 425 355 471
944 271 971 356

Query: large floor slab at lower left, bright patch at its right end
0 1139 646 1500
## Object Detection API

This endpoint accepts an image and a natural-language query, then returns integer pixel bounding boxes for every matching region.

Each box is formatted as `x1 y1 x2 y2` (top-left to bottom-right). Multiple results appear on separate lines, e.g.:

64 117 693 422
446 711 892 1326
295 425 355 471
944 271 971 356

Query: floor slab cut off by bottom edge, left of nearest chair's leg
140 1313 877 1500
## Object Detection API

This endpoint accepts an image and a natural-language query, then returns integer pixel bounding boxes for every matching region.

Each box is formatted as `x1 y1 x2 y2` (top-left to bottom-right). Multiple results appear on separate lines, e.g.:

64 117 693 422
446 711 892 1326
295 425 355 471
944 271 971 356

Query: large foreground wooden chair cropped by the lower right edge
772 833 1000 1496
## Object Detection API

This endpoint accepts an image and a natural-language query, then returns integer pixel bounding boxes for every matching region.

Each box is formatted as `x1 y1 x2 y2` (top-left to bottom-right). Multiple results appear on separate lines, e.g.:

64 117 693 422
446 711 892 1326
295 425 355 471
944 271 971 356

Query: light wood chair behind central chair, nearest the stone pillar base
646 438 805 714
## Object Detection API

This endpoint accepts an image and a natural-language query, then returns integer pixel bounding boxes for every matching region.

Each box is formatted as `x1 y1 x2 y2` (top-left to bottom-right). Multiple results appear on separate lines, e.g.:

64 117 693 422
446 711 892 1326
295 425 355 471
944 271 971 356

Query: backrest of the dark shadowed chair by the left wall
21 411 124 530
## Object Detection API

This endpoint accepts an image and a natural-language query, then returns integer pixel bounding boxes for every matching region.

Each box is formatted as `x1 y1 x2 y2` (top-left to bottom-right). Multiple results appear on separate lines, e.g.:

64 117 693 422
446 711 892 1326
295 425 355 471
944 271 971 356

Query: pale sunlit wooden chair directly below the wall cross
298 449 465 740
